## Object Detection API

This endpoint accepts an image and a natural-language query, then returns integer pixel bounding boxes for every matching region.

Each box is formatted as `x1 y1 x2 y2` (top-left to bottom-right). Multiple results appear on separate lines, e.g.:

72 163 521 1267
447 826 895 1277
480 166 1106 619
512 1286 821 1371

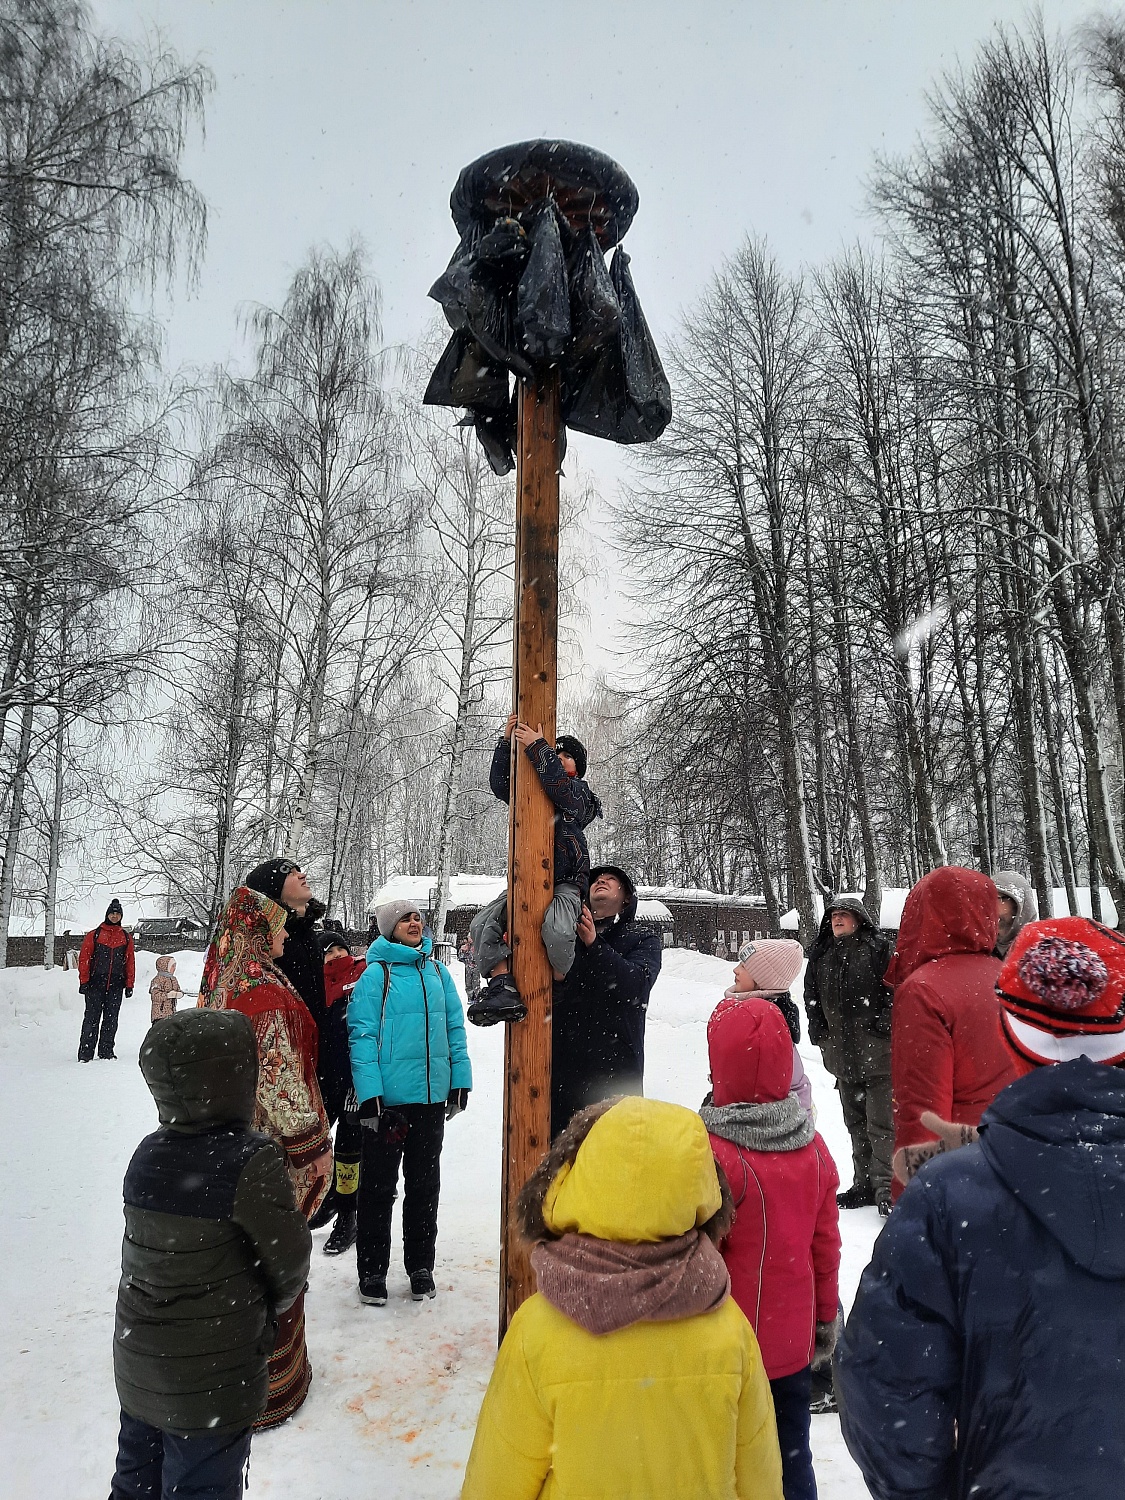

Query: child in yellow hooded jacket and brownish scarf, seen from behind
461 1098 782 1500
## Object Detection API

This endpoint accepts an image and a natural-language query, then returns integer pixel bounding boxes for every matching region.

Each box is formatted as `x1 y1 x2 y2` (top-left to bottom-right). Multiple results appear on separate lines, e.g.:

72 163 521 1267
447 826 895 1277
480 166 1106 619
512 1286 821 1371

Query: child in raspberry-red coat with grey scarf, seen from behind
699 999 840 1500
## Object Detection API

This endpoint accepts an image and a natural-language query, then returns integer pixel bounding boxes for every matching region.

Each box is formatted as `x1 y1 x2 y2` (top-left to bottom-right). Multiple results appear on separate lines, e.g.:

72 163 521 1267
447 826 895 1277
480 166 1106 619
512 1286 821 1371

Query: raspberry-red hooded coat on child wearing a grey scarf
708 999 840 1380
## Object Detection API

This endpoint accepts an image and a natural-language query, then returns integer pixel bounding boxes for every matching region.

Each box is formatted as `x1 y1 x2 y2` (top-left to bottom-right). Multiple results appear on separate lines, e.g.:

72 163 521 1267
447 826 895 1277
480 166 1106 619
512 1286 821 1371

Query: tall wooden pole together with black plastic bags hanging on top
423 141 672 1338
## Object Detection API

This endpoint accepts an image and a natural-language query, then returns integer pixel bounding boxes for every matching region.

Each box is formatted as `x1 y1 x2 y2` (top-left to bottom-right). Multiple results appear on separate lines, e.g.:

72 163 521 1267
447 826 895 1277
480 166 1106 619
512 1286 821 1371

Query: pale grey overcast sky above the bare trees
93 0 1092 651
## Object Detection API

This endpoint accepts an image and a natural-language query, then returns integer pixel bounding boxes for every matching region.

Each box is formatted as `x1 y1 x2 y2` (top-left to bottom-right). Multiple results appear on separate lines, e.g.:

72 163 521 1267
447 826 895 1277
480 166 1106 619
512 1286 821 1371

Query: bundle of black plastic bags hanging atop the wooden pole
425 141 672 474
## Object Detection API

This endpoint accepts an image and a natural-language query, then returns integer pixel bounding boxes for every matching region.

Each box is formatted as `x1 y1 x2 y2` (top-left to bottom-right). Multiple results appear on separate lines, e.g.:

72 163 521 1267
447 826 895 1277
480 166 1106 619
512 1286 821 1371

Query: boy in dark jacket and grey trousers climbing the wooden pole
467 714 602 1026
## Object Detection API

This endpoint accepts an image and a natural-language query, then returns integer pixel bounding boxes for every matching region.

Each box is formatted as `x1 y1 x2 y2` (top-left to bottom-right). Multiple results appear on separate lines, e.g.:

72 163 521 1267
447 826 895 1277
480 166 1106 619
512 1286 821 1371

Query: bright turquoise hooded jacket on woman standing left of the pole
348 936 473 1104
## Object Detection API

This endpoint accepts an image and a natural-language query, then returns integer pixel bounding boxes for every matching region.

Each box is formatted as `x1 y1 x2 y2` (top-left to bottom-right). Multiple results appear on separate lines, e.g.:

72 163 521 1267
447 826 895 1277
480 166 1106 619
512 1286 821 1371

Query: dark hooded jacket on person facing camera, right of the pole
804 896 893 1079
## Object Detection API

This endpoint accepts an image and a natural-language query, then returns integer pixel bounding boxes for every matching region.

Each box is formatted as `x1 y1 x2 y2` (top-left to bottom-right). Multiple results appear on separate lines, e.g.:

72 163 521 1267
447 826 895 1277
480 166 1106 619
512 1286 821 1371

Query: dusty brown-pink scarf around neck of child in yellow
531 1229 731 1334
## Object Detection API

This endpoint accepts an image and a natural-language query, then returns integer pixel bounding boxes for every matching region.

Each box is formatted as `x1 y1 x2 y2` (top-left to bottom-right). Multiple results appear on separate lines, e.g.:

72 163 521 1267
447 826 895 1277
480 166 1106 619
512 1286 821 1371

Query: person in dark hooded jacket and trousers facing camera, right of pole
804 896 894 1214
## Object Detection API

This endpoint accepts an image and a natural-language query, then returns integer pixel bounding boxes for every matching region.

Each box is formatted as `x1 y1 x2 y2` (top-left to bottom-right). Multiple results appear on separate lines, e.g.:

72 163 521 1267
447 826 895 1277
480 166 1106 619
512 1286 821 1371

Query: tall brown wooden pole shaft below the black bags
500 371 560 1338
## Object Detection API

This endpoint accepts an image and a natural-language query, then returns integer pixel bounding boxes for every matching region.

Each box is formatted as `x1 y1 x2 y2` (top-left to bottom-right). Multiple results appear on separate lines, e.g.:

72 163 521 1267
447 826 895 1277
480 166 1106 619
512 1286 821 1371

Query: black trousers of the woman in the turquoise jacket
356 1103 446 1281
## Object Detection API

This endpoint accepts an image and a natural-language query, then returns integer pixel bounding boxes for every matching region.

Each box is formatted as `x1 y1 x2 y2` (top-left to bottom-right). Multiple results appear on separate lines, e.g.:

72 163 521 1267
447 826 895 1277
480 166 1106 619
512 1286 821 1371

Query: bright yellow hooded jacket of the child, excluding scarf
461 1098 782 1500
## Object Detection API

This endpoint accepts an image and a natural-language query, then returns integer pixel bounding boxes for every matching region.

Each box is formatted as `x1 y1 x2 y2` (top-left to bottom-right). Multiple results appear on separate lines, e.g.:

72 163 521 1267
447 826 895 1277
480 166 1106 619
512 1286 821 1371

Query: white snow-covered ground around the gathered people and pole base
0 950 879 1500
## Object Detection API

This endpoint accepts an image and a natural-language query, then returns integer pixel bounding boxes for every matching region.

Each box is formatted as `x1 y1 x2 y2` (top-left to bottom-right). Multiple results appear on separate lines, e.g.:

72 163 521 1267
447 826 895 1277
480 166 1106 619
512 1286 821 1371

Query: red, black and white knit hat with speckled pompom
996 917 1125 1067
